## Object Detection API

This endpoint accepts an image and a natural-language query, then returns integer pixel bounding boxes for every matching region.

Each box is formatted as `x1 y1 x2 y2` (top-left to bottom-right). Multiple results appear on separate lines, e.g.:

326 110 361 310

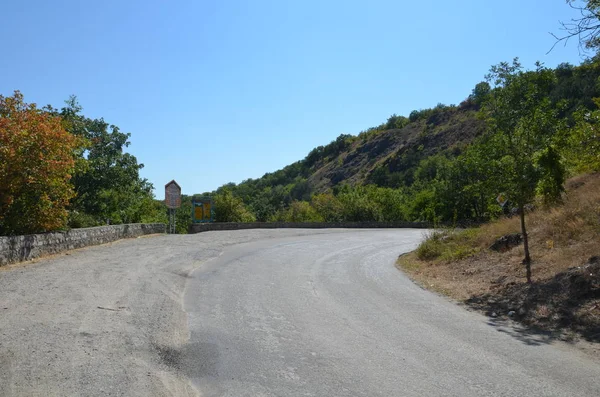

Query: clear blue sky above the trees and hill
0 0 582 199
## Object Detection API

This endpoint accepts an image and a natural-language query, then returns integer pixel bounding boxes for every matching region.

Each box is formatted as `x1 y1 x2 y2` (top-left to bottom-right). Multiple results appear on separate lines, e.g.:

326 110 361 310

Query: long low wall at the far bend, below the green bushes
189 222 431 233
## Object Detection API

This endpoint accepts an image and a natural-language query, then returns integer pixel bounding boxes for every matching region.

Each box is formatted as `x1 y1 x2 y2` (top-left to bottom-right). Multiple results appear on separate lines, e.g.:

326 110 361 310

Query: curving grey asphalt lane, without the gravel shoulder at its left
183 230 600 397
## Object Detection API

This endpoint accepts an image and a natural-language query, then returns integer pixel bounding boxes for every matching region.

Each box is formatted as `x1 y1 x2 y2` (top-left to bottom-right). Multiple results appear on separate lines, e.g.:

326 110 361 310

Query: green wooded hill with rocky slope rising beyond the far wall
188 59 600 229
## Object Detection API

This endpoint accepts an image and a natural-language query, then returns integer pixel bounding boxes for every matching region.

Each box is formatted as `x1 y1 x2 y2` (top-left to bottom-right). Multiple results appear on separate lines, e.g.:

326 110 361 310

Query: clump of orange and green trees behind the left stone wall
0 91 167 235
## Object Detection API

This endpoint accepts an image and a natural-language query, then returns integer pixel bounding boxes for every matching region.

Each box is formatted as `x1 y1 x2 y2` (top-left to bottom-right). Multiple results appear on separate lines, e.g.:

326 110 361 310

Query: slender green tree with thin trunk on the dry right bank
482 59 565 282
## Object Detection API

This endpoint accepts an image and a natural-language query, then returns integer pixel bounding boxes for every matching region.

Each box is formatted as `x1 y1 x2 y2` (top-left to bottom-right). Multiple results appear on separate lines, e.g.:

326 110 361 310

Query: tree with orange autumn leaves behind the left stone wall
0 91 81 235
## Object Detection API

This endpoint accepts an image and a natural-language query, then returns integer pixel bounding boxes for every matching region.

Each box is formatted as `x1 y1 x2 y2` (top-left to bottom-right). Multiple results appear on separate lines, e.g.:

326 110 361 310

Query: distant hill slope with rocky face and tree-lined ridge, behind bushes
225 100 484 201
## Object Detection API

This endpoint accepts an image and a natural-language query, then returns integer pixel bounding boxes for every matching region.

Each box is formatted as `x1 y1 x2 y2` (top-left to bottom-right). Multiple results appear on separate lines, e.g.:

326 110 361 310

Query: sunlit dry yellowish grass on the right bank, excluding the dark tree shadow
398 173 600 338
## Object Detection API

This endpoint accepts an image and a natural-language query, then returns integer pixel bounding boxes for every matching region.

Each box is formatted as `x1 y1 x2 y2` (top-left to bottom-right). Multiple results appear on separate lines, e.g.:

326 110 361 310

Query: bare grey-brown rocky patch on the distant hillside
308 106 483 192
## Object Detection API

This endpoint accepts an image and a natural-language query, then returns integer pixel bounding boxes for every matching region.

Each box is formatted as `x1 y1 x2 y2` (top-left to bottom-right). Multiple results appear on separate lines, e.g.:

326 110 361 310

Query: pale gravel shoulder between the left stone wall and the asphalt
0 229 344 396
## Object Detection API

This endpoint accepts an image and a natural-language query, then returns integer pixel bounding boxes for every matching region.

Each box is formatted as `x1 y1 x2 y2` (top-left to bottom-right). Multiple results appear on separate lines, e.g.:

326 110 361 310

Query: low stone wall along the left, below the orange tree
0 223 166 266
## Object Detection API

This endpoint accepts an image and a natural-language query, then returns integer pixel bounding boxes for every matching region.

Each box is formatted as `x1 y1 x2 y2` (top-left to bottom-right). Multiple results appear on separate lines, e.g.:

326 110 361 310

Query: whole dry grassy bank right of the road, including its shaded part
398 172 600 342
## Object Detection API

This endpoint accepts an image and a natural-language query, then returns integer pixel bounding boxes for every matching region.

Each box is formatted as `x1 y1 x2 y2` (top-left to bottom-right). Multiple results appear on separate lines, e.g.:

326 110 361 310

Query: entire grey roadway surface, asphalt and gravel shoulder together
0 229 600 397
